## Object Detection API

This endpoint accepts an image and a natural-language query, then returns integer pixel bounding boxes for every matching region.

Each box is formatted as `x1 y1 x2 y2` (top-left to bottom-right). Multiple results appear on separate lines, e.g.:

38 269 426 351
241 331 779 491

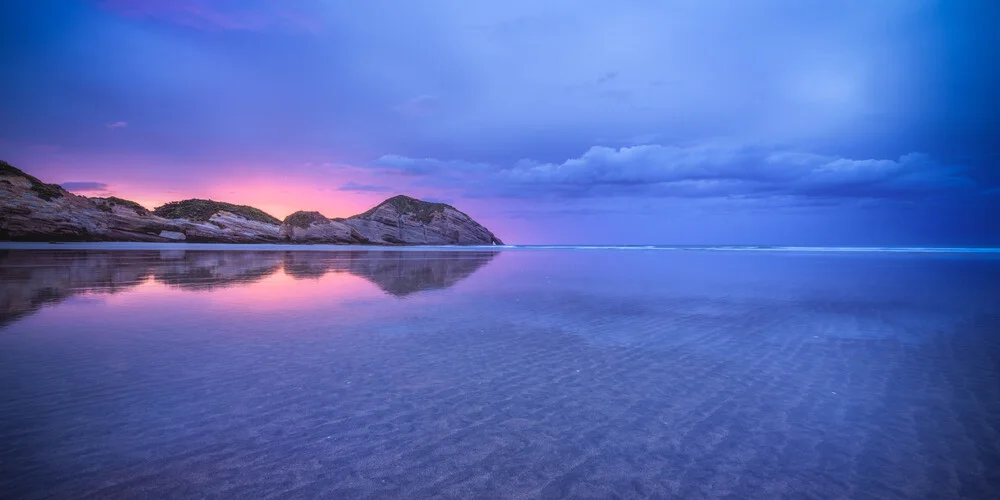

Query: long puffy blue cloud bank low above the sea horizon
380 144 976 199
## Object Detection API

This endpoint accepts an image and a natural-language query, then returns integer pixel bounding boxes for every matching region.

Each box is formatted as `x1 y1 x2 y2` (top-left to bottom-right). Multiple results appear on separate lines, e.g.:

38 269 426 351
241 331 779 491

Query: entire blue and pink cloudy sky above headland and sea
0 0 1000 245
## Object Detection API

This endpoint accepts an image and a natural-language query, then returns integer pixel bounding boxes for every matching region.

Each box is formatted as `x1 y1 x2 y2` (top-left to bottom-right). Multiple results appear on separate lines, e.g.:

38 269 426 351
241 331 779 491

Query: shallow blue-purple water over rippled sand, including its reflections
0 246 1000 499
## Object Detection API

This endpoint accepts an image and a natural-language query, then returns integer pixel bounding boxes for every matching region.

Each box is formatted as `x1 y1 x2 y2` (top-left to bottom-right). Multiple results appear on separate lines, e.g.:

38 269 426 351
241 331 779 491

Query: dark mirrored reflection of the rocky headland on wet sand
0 250 497 326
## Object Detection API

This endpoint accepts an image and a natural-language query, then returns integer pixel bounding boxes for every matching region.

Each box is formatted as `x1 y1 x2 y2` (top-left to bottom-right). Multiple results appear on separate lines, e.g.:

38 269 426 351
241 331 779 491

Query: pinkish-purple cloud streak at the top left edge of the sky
100 0 321 33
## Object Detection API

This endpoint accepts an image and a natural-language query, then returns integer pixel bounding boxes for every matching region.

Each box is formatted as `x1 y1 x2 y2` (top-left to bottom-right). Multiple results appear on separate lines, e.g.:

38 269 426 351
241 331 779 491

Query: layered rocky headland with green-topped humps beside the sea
0 161 503 245
